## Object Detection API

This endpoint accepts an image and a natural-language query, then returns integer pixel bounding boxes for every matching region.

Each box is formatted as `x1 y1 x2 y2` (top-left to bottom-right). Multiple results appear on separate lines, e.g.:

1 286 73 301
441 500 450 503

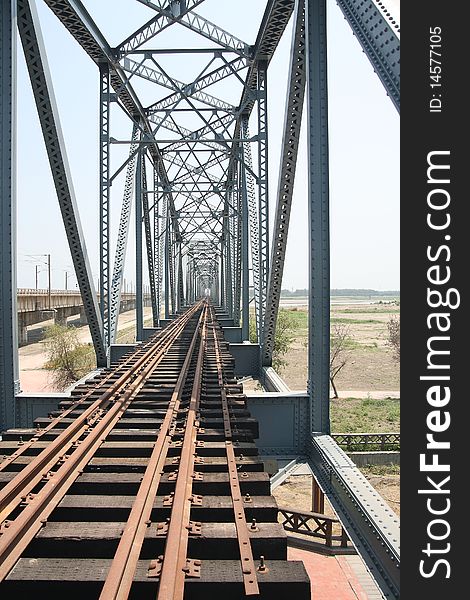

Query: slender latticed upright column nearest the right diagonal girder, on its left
258 60 269 350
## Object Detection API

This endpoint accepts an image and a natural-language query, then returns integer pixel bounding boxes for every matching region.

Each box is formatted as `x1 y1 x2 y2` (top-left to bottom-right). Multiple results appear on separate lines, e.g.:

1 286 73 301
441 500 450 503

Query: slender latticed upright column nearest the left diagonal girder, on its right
99 63 111 348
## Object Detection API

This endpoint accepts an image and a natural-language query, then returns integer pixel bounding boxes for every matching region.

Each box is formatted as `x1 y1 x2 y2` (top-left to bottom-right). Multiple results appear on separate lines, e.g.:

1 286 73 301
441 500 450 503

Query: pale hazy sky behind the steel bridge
14 0 399 289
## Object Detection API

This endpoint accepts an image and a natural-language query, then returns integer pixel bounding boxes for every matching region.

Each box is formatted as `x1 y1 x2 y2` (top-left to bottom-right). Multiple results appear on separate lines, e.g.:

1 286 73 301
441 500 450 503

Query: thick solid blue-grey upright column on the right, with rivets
306 0 330 433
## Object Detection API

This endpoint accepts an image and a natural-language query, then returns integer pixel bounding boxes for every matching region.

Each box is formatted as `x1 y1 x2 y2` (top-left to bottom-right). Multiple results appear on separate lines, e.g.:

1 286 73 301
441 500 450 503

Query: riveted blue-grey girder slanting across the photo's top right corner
338 0 400 112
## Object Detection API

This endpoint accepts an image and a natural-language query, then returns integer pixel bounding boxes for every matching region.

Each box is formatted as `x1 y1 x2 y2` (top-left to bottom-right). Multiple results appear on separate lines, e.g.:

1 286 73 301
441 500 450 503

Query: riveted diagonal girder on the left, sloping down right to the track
18 0 106 366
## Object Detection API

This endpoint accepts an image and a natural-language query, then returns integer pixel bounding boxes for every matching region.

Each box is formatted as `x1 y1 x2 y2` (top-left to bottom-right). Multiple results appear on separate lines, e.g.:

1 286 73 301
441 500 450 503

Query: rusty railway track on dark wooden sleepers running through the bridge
0 300 310 600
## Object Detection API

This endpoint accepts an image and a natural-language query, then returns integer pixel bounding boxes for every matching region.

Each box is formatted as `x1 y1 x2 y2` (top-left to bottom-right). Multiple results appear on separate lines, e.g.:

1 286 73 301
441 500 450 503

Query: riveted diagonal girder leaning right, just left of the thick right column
262 0 306 366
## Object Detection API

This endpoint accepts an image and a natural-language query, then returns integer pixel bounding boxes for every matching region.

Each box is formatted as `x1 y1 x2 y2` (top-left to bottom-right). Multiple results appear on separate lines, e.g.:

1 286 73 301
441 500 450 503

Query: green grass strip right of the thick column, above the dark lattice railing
330 398 400 433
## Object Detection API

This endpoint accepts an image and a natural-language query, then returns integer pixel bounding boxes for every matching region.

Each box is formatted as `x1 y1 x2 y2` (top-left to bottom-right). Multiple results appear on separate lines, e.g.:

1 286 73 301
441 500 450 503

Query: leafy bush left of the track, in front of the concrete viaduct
45 325 95 390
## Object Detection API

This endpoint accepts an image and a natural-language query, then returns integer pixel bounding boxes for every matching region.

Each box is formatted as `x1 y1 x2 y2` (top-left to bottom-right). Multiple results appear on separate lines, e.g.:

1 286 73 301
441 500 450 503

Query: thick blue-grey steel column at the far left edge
0 0 20 431
